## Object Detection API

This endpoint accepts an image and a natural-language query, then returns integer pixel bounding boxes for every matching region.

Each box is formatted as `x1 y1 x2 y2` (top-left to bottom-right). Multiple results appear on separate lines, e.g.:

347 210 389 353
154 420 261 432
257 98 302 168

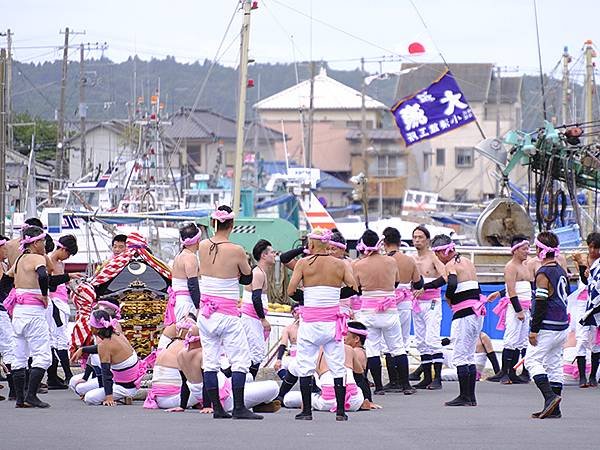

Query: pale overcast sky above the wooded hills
0 0 600 78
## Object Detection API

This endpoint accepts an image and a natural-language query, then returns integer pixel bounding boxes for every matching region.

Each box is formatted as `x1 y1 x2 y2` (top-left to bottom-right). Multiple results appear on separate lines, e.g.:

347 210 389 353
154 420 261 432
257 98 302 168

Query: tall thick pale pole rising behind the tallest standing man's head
233 0 252 214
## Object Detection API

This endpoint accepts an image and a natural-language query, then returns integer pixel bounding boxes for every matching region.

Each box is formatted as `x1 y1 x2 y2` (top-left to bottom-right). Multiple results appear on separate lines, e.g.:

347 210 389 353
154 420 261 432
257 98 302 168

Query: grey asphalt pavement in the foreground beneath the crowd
0 382 600 450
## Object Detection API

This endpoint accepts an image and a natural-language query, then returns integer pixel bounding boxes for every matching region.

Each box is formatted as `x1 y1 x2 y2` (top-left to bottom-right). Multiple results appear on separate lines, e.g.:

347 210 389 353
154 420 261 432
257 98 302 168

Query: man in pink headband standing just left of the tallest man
167 223 202 322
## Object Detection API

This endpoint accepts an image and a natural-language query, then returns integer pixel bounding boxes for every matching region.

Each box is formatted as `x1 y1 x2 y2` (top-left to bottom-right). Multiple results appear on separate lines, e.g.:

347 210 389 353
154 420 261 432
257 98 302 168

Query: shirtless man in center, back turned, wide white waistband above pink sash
288 228 356 421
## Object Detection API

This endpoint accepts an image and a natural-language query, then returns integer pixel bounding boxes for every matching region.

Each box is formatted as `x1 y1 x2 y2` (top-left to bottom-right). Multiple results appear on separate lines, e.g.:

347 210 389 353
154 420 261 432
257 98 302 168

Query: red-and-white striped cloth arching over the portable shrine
71 232 171 352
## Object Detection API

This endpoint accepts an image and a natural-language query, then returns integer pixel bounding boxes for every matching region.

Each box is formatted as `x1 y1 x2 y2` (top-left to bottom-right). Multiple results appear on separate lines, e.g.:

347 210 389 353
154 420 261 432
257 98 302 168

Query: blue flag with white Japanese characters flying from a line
392 70 475 146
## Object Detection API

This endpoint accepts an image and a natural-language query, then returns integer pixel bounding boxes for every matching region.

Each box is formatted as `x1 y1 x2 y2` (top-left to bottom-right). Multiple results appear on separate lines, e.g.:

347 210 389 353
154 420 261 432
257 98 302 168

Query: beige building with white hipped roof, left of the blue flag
254 68 388 179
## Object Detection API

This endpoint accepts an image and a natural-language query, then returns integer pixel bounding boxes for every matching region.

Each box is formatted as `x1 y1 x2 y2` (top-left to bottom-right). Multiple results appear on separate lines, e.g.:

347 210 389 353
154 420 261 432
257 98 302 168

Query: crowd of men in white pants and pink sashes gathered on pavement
0 206 600 421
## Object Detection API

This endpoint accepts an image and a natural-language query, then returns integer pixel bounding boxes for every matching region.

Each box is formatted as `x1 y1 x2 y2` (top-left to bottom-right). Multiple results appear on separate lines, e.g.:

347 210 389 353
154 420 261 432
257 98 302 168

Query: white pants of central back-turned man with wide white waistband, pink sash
296 322 346 378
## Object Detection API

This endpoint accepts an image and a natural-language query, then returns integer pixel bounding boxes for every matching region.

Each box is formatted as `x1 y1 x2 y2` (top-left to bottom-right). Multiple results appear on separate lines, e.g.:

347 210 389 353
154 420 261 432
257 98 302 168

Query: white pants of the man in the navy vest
525 330 568 383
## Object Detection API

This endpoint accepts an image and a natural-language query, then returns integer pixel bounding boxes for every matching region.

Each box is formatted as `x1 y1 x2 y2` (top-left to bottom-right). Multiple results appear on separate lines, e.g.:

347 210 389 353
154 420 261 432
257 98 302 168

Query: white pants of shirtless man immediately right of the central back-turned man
362 309 406 358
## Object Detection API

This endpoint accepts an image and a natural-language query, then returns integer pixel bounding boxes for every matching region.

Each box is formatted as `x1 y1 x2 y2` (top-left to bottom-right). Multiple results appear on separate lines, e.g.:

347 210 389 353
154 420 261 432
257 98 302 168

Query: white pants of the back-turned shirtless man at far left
12 305 52 370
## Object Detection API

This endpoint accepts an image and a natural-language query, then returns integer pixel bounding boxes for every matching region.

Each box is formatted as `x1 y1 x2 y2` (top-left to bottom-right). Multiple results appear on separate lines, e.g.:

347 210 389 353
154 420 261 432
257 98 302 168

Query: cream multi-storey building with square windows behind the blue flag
396 63 526 201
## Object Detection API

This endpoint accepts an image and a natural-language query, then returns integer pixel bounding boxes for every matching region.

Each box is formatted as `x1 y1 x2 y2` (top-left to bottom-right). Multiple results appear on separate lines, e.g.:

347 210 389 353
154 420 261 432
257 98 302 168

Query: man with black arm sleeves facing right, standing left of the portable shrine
46 234 80 389
